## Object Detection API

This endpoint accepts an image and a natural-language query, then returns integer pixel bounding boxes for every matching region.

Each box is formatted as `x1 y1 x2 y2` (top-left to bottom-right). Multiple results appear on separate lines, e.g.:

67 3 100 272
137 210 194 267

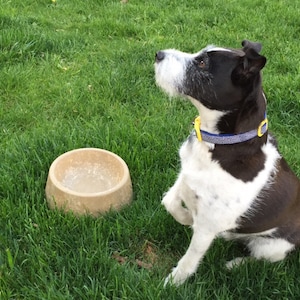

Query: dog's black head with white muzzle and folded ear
155 40 266 112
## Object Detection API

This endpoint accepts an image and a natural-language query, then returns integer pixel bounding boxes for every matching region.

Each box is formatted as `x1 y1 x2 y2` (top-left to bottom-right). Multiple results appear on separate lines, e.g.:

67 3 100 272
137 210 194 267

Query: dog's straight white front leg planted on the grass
164 226 215 286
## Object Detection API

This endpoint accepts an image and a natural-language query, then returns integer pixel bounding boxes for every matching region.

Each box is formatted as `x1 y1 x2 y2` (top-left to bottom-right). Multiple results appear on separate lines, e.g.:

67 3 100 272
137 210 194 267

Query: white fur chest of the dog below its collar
180 136 277 230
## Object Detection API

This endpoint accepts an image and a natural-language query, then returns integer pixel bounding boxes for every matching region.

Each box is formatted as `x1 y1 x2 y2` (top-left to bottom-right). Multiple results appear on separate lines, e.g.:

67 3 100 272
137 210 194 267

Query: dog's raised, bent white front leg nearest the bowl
162 175 193 225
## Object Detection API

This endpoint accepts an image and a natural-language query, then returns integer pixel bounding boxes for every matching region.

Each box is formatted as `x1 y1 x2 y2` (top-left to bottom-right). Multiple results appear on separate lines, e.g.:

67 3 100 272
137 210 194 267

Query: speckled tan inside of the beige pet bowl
53 148 125 194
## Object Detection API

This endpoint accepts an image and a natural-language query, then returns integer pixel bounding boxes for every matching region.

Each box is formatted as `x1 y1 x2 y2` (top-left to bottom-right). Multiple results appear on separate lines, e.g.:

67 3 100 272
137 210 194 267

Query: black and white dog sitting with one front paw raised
155 41 300 285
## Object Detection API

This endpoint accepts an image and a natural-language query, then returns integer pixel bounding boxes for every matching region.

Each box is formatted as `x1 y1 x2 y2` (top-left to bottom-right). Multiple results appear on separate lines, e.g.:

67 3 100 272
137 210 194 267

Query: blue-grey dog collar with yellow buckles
194 113 268 145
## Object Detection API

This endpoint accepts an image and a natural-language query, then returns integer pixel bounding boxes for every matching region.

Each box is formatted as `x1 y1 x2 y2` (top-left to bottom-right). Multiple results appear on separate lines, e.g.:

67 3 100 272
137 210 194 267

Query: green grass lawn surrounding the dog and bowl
0 0 300 300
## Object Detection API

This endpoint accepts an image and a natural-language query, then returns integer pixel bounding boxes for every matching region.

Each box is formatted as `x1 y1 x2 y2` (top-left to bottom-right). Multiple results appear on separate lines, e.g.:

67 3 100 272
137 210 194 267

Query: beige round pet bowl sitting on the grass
46 148 132 216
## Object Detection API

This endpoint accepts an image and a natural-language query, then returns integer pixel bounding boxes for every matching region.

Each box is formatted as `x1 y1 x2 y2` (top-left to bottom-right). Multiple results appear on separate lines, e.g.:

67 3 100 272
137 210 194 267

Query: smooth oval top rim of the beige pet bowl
48 148 130 198
